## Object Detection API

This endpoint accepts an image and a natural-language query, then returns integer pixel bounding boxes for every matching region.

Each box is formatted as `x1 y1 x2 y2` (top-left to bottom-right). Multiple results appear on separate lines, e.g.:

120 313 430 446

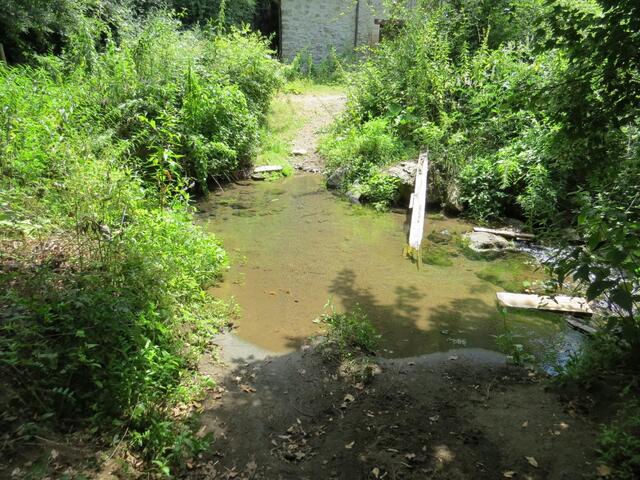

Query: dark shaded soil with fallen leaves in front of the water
188 340 596 480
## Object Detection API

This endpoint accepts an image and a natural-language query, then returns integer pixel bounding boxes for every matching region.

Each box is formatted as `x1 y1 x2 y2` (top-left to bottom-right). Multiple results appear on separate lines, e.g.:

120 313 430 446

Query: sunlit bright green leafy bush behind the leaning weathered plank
329 2 584 226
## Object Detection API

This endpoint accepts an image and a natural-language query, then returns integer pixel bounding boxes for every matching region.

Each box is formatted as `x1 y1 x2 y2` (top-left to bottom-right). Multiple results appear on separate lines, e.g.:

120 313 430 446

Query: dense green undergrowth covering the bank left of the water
0 6 281 473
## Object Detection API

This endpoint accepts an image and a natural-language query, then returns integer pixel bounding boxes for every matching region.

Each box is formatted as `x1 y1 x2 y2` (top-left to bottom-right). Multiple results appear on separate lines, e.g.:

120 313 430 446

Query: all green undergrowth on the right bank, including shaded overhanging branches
321 0 640 478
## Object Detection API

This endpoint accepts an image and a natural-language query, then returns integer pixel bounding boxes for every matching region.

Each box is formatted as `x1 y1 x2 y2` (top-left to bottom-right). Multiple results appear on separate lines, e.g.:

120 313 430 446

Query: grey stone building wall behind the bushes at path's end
280 0 384 62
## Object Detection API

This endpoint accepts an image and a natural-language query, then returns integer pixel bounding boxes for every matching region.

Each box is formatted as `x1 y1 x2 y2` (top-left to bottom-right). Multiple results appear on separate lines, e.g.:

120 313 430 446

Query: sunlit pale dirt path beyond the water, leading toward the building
290 93 347 172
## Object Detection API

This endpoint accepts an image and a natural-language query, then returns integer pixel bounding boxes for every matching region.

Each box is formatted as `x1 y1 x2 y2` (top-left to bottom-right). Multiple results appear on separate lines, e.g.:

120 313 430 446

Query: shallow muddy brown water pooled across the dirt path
198 174 567 357
